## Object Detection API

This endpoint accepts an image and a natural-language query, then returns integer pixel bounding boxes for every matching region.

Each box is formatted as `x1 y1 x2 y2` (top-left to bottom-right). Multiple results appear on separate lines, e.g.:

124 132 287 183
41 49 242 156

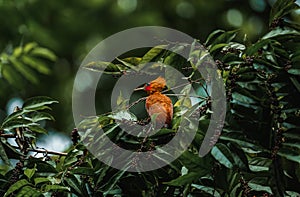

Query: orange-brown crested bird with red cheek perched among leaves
144 76 173 129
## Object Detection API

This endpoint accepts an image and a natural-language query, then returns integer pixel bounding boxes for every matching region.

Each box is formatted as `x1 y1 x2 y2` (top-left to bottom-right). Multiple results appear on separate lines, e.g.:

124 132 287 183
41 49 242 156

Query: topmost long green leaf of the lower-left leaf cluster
22 96 58 110
